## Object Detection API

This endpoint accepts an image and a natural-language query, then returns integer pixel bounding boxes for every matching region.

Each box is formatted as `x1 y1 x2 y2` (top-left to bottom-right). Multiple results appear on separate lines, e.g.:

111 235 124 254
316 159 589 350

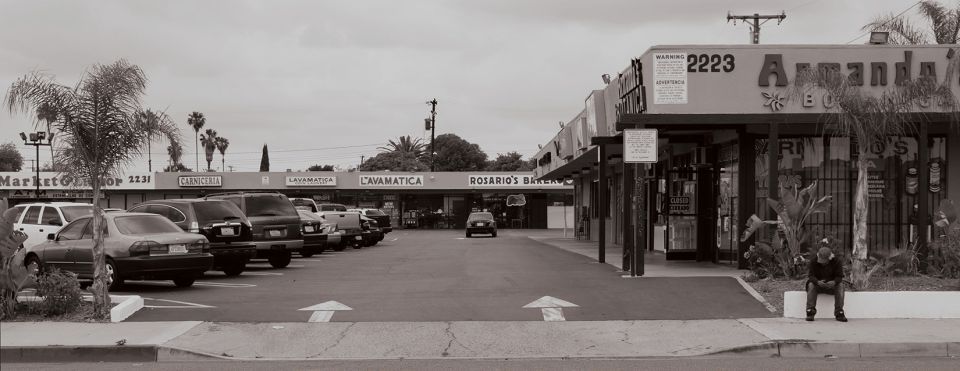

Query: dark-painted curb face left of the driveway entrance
0 345 157 363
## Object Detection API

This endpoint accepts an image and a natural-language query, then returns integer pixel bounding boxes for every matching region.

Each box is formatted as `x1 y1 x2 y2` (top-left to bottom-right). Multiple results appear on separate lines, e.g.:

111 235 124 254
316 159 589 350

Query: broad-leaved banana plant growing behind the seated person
740 181 833 277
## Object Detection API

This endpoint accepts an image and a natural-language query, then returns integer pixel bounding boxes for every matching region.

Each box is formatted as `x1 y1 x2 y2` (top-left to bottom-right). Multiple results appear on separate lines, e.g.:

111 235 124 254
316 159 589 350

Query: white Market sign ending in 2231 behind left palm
0 171 156 191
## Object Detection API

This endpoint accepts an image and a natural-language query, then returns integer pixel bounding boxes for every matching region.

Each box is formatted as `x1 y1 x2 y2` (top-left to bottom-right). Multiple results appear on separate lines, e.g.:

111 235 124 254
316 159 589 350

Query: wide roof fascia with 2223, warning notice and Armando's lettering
640 45 960 114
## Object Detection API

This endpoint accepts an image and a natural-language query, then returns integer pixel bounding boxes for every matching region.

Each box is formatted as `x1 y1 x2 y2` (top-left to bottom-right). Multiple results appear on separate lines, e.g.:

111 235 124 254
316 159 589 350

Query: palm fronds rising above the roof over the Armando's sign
862 0 960 45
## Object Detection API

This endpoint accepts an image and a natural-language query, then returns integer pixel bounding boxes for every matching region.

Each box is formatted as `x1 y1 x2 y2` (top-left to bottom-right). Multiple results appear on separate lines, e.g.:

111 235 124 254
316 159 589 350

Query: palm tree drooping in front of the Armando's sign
791 53 960 290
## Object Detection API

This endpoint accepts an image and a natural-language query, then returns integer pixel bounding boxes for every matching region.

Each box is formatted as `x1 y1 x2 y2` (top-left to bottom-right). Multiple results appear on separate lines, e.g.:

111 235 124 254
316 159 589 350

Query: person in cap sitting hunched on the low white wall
807 247 847 322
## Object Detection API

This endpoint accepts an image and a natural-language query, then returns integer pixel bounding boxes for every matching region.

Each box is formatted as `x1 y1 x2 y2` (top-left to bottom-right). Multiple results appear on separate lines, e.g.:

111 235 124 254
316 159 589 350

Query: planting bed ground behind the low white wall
749 276 960 315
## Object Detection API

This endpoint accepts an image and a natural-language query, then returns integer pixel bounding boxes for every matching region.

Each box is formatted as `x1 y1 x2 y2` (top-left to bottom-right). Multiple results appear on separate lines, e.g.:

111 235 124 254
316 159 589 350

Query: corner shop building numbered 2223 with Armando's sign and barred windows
535 45 960 268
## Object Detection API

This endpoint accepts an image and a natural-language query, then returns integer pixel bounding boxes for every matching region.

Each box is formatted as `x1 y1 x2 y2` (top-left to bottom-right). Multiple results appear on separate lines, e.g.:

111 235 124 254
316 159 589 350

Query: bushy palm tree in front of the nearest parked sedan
4 59 158 318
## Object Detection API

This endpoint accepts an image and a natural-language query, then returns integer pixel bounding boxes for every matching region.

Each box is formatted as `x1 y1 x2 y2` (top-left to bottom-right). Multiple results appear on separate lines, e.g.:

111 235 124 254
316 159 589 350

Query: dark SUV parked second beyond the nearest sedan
205 192 303 268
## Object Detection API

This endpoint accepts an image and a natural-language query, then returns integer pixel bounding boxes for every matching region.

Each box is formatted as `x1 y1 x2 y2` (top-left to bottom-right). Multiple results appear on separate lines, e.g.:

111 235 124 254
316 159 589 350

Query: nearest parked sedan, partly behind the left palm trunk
25 212 213 290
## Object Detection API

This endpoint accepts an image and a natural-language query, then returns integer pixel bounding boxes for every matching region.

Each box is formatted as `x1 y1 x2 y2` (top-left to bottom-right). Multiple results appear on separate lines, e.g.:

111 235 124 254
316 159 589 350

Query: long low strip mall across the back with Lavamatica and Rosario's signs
0 172 573 228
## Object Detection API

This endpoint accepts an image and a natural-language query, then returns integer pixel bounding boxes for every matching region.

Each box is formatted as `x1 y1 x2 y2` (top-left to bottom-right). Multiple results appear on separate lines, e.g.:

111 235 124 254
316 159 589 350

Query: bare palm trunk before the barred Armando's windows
851 147 869 290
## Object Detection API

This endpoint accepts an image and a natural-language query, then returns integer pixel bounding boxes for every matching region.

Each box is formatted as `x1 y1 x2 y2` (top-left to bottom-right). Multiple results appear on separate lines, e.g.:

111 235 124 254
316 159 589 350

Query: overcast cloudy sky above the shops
0 0 928 171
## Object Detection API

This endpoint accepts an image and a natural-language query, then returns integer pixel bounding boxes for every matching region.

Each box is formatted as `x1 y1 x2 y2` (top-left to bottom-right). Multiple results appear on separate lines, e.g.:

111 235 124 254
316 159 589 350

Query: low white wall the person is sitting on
783 291 960 318
